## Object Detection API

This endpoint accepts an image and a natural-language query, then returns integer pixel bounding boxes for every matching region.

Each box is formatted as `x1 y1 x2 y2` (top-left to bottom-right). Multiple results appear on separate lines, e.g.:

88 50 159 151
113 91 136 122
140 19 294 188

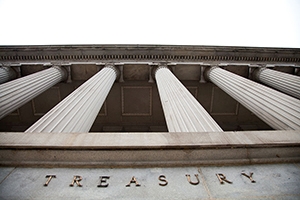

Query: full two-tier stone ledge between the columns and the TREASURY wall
0 131 300 167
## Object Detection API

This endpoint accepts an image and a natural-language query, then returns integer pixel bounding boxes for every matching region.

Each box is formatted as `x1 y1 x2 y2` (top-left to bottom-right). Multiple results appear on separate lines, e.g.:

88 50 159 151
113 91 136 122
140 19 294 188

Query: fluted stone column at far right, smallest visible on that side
253 68 300 99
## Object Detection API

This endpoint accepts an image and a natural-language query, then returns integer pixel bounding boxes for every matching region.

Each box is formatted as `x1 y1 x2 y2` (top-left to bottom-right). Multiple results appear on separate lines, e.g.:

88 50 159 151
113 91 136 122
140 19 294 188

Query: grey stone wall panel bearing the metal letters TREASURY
0 163 300 200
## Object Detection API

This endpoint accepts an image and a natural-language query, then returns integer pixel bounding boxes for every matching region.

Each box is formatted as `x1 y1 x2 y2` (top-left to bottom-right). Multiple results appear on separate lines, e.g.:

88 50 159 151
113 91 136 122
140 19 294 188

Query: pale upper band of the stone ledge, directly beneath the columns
0 131 300 149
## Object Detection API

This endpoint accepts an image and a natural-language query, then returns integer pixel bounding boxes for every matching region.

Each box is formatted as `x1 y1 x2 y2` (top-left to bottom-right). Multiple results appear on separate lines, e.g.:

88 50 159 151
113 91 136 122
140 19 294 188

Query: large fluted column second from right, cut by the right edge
206 67 300 130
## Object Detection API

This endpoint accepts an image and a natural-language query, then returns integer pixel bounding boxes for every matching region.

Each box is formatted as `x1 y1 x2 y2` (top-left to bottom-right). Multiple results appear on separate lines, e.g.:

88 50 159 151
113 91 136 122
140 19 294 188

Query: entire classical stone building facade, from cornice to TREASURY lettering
0 45 300 199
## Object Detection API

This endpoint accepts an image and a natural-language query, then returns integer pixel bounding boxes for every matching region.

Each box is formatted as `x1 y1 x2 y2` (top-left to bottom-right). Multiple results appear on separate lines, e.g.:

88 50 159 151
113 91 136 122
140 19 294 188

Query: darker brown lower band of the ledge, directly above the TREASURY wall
0 147 300 167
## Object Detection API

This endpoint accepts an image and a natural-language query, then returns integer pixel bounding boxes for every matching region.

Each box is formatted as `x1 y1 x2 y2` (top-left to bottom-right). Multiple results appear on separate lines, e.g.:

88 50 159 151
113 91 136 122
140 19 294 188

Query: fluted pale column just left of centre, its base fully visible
25 66 118 133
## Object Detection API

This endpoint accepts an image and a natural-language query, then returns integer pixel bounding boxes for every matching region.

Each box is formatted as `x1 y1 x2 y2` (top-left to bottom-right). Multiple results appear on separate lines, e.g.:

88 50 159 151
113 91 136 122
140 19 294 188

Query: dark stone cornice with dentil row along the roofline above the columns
0 45 300 63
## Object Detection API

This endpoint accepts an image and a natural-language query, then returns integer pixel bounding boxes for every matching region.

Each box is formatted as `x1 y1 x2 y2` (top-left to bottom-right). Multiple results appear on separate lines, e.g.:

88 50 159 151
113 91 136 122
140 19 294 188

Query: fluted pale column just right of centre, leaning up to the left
155 66 222 132
